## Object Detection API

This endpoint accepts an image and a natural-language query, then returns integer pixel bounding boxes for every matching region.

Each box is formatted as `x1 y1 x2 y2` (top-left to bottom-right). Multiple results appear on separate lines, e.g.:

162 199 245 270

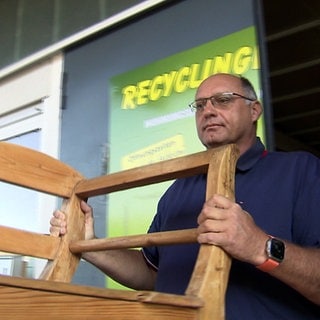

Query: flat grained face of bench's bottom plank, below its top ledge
0 285 199 320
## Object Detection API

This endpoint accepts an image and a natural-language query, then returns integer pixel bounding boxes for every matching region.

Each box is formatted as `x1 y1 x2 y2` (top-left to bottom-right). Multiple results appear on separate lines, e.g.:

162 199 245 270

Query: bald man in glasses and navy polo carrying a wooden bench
50 74 320 320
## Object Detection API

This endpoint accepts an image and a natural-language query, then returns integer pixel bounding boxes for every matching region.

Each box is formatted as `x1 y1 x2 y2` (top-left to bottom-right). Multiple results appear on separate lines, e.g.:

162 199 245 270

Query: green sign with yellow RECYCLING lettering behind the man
107 27 264 287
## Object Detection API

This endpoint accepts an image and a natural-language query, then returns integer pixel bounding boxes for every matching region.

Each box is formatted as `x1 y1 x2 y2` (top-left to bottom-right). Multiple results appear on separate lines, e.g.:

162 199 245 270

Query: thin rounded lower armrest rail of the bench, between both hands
69 229 198 253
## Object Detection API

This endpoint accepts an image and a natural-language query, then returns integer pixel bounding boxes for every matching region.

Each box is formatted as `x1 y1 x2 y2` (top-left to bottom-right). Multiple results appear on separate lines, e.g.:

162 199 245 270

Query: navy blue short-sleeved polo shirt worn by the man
143 138 320 320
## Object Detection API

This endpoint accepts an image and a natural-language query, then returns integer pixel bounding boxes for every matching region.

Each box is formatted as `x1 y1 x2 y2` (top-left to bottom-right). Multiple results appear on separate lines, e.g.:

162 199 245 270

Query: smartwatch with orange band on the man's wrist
257 236 285 272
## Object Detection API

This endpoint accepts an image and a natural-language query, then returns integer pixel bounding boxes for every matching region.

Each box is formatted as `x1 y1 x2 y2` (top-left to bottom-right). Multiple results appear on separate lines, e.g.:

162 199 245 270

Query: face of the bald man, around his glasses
196 75 261 148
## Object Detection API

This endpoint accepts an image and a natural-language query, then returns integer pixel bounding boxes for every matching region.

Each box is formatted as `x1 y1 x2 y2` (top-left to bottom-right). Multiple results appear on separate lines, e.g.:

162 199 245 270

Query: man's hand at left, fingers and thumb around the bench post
50 201 95 240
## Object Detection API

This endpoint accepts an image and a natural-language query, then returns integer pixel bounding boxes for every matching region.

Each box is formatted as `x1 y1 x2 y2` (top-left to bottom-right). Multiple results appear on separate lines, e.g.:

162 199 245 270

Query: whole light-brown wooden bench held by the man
0 142 238 320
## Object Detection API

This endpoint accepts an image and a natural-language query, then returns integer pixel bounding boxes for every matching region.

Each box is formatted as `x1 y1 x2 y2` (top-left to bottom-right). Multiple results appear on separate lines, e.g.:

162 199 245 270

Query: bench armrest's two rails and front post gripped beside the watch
70 145 239 319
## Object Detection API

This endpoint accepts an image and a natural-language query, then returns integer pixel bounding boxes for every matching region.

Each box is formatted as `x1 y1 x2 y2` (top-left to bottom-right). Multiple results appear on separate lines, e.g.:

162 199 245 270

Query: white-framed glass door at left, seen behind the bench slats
0 56 62 278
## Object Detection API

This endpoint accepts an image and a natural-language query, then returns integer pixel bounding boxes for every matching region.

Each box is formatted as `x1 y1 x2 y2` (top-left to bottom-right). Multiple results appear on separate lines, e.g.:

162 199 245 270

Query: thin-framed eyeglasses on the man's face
189 92 256 111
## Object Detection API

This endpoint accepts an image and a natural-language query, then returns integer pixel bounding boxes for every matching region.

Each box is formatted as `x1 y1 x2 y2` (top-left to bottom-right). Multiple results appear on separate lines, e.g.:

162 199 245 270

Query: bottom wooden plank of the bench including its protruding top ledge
0 276 203 320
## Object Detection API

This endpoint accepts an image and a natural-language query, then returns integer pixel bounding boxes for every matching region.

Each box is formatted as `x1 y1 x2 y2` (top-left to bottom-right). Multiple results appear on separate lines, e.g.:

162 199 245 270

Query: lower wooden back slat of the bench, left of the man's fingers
0 226 61 260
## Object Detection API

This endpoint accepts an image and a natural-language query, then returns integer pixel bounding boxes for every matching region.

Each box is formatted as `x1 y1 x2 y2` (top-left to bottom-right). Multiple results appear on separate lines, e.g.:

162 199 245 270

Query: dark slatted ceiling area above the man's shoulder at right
262 0 320 157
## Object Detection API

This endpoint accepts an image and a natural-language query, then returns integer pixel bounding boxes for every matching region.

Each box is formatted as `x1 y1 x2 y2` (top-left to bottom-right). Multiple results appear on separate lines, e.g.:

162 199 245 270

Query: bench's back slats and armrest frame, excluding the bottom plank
0 142 238 319
